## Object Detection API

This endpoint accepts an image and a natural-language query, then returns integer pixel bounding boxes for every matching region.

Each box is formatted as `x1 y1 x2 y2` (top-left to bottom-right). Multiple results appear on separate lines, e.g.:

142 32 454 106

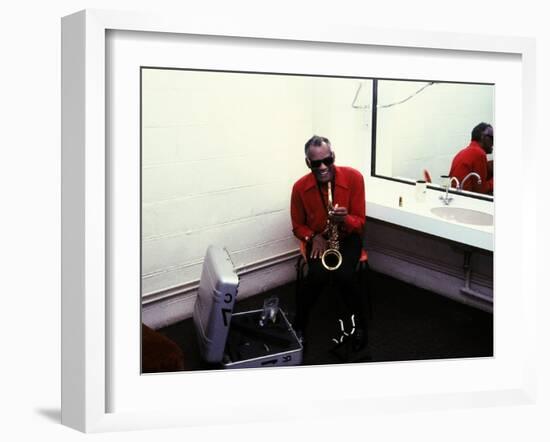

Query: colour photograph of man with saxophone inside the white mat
139 66 498 374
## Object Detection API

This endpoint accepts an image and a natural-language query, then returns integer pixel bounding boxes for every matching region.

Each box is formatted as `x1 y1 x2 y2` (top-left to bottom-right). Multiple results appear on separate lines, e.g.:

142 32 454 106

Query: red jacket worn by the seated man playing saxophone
290 166 365 241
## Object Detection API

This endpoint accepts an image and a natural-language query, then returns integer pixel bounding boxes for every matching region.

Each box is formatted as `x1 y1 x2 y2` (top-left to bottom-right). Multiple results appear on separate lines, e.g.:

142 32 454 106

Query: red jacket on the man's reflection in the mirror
449 141 493 193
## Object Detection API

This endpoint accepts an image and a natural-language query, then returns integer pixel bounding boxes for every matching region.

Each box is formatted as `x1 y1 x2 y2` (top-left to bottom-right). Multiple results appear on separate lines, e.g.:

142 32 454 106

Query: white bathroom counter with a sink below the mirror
366 180 494 251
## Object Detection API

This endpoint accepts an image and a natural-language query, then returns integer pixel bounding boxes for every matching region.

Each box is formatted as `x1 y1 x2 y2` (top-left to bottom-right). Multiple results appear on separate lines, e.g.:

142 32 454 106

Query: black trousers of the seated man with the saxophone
294 234 366 332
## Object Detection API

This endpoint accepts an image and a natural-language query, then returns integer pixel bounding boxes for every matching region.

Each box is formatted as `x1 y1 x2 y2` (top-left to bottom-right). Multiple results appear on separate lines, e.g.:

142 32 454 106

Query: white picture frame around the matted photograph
62 10 536 432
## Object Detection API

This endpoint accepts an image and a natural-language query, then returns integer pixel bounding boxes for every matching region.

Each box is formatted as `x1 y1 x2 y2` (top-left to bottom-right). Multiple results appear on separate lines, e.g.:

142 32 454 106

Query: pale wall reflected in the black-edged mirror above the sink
372 80 494 199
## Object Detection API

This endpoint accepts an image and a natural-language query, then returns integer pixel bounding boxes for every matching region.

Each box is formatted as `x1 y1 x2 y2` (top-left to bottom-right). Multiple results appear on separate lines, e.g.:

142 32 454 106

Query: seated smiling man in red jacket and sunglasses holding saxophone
290 135 365 350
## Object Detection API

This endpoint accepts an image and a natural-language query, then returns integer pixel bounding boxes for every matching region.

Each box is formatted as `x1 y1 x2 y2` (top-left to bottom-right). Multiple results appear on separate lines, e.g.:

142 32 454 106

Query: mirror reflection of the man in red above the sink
449 123 493 194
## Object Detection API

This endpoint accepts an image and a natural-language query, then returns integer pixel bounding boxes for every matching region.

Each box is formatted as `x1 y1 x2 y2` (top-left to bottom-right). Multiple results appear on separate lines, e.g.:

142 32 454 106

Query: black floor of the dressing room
158 271 493 370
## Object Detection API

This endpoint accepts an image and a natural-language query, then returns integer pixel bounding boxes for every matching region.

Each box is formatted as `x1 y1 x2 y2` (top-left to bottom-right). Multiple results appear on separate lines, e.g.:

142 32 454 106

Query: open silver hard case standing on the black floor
193 246 303 368
